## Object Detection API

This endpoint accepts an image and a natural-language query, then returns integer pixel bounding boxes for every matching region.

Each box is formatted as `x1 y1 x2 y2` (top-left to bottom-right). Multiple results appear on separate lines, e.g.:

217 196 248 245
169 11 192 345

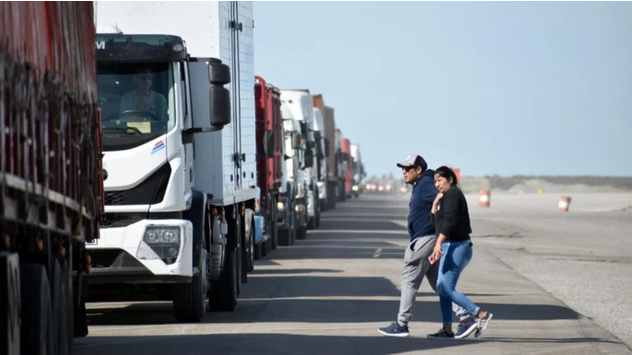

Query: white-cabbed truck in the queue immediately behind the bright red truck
277 102 307 246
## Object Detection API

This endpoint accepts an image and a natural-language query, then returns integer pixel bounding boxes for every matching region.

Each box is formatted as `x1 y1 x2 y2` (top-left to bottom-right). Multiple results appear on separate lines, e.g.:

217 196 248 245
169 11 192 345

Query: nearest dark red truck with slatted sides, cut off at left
0 1 103 355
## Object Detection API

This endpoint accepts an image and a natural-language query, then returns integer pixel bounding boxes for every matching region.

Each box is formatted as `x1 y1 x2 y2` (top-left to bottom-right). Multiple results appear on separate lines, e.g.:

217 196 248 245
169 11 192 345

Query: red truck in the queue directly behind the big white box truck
255 76 284 258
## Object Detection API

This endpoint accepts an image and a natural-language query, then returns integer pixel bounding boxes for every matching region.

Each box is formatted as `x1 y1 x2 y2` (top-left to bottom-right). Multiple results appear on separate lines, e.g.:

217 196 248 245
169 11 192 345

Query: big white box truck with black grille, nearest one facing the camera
89 1 257 322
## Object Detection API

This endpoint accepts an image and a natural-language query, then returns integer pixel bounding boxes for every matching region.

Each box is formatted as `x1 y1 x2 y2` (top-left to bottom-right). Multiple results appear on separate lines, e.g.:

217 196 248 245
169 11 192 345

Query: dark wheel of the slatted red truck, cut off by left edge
0 253 20 355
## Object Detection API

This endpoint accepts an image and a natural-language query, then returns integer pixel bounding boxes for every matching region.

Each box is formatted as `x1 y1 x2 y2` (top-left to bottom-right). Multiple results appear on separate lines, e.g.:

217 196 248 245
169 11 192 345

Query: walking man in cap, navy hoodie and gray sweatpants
378 155 476 339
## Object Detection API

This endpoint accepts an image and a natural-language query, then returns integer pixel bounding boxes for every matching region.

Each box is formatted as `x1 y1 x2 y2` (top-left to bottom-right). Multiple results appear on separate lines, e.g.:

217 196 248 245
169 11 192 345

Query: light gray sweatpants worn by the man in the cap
397 235 470 324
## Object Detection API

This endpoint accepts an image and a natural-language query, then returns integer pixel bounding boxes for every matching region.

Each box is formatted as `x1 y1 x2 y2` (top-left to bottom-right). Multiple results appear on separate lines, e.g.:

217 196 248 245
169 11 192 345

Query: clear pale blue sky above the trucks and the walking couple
254 2 632 176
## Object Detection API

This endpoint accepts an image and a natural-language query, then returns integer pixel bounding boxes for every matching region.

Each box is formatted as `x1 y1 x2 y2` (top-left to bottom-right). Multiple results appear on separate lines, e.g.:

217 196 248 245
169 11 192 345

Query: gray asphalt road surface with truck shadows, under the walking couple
75 194 632 355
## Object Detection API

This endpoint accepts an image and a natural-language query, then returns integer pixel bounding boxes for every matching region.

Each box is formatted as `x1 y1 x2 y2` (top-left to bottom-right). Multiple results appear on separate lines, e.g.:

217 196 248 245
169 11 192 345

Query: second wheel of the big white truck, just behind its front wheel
209 250 237 312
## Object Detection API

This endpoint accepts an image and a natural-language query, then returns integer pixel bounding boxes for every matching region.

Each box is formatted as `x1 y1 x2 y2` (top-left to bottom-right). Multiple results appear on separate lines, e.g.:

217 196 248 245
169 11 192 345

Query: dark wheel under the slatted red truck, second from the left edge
20 264 55 355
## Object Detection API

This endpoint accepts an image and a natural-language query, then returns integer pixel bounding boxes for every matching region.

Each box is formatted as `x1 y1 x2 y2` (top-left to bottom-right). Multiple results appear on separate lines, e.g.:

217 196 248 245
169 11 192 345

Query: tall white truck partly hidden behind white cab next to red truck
281 90 320 229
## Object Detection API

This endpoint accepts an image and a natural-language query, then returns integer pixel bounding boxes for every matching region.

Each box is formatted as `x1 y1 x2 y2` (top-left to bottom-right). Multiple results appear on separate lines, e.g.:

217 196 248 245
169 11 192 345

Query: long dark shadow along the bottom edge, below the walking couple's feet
74 334 616 355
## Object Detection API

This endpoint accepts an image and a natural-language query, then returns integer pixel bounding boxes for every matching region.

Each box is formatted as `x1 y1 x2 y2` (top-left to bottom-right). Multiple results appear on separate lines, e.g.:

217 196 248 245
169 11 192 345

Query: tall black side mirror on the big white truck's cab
208 58 231 128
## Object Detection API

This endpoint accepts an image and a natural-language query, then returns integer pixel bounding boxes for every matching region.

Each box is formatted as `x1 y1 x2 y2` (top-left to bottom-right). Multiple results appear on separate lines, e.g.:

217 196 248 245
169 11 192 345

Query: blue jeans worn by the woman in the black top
437 239 480 324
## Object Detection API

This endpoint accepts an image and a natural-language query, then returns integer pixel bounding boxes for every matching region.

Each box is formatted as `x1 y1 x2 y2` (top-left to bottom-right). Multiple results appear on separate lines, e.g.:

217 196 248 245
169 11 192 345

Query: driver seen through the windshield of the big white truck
120 68 168 122
